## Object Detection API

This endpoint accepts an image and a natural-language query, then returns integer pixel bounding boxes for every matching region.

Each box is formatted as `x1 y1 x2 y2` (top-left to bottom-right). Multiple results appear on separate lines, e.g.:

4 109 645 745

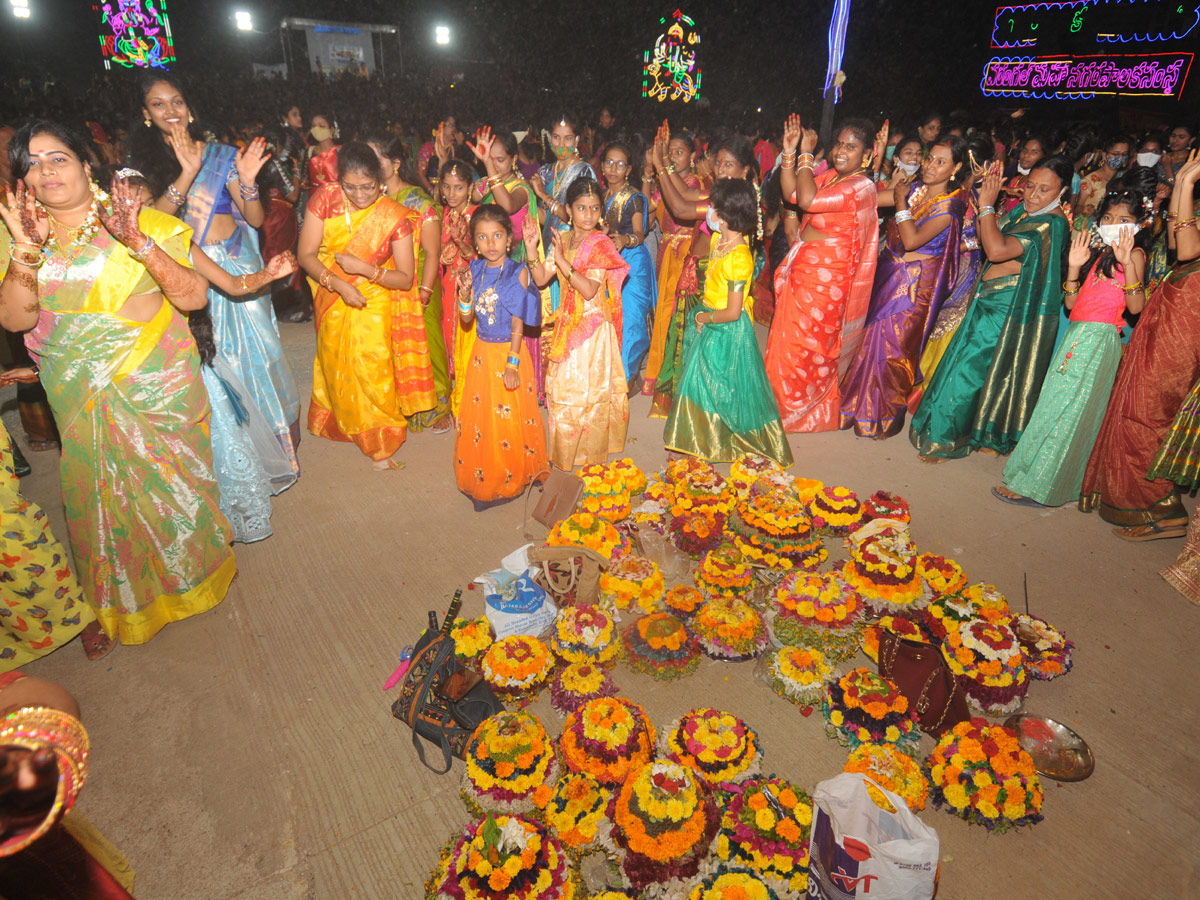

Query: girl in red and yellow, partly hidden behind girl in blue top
438 160 475 419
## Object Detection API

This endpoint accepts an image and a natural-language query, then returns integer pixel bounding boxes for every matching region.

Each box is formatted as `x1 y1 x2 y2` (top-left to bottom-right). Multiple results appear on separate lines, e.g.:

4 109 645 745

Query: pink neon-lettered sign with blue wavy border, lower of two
979 53 1195 100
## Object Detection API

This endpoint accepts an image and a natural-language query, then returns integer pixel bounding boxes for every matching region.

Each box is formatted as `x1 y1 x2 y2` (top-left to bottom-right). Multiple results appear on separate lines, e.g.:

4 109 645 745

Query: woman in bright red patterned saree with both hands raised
764 115 878 432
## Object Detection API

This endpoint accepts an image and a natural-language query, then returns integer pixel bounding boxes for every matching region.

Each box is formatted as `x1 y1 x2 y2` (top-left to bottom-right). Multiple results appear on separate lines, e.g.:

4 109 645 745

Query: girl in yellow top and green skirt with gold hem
664 179 792 466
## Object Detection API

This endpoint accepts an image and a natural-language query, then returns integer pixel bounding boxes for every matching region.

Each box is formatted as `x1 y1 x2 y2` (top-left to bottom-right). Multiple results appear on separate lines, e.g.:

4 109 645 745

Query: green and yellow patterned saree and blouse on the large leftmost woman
0 210 236 644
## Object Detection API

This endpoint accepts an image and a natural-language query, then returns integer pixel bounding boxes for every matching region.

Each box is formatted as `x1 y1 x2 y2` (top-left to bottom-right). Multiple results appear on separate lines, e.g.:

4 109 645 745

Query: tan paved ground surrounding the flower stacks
0 325 1200 900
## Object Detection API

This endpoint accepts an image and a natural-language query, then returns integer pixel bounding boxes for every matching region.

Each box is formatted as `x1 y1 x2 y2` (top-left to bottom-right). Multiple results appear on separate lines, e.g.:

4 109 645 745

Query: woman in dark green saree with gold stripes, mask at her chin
910 156 1072 461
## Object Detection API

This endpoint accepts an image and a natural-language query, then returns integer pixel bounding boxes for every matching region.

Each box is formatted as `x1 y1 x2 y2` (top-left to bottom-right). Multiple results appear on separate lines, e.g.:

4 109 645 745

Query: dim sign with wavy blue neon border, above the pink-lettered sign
991 0 1200 53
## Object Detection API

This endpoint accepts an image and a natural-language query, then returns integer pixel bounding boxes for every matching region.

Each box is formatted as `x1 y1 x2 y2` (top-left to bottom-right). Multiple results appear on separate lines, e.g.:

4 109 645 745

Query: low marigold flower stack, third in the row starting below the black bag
661 707 762 788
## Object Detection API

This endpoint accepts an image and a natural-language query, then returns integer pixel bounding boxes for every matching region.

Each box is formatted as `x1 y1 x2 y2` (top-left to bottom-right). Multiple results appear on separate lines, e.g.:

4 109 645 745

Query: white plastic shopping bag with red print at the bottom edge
809 773 938 900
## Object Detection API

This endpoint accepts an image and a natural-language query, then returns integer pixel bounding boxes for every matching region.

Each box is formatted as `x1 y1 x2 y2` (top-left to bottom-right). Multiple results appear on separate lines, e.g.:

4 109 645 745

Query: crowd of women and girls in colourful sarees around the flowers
0 76 1200 668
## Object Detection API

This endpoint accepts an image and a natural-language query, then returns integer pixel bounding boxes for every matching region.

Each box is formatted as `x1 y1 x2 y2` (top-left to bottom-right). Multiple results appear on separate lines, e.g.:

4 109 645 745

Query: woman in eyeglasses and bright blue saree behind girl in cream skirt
600 140 659 396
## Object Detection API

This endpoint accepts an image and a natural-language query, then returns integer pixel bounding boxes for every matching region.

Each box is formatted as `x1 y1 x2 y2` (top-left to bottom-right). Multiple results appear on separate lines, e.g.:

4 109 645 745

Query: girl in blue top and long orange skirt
454 203 547 511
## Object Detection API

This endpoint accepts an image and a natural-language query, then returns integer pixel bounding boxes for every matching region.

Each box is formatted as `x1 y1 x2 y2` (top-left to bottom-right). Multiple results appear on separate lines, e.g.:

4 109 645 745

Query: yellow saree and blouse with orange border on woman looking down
308 185 437 461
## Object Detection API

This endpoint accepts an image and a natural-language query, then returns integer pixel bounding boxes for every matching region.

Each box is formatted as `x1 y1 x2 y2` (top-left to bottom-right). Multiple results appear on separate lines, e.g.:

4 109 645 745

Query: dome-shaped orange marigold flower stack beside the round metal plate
925 719 1043 834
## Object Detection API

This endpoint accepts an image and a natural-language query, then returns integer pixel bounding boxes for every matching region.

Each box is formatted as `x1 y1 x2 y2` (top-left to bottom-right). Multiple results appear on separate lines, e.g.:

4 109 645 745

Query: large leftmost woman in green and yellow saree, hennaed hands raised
0 121 236 655
